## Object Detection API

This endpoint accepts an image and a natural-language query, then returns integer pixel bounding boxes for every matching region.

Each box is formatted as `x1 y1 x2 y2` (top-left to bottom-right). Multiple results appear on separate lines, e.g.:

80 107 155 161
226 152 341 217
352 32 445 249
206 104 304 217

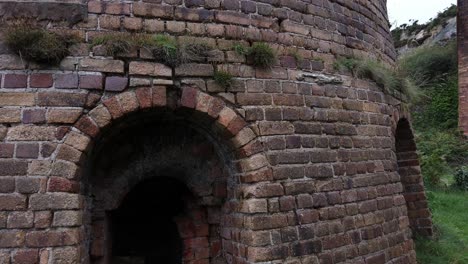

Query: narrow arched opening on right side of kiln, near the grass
395 119 432 236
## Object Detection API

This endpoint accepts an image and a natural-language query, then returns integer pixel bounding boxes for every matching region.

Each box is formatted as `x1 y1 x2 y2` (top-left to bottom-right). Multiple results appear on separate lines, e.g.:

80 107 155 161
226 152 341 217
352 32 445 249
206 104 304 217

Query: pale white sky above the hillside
387 0 457 25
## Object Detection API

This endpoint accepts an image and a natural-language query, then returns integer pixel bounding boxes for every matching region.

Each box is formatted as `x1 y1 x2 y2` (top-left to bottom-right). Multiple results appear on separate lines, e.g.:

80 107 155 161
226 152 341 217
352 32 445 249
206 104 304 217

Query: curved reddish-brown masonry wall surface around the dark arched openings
0 0 430 264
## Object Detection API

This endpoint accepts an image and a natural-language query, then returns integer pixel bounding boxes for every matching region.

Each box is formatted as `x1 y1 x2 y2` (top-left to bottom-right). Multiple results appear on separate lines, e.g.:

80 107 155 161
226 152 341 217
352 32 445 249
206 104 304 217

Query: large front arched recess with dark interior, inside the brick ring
83 111 236 264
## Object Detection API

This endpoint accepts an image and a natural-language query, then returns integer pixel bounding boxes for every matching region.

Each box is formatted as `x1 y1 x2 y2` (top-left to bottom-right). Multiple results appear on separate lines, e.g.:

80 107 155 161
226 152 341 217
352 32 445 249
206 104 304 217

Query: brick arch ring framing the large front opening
48 86 271 262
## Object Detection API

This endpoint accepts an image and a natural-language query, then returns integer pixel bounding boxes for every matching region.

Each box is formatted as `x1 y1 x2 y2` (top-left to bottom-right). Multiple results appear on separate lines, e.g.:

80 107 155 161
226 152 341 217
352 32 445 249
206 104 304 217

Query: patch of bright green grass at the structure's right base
416 189 468 264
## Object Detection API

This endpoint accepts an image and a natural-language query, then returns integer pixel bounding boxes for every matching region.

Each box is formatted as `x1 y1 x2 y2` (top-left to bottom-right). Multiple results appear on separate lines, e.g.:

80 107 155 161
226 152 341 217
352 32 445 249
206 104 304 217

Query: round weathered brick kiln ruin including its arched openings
0 0 434 264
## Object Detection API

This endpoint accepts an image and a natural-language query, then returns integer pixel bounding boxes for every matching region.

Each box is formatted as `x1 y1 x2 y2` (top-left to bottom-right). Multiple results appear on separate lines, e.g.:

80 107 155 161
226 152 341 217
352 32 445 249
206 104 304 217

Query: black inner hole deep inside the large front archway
109 178 190 264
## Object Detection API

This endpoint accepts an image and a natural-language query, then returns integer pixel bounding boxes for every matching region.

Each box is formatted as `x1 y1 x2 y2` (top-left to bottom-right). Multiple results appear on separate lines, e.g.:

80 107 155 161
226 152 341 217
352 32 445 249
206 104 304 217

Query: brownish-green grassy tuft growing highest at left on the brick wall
5 22 77 65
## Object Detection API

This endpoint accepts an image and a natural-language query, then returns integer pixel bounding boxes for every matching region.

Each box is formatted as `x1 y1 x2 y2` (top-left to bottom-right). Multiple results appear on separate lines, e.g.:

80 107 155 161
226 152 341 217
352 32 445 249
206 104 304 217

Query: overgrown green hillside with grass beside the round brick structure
396 4 468 264
